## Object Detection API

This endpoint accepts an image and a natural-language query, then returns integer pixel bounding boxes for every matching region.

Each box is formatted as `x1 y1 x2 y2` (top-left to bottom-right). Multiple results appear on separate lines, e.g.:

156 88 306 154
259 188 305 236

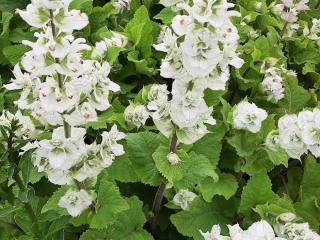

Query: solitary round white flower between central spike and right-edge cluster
233 101 268 133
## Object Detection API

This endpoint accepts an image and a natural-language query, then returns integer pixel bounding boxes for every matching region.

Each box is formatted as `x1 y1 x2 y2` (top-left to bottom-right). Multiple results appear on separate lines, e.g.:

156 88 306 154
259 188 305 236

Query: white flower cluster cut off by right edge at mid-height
266 108 320 159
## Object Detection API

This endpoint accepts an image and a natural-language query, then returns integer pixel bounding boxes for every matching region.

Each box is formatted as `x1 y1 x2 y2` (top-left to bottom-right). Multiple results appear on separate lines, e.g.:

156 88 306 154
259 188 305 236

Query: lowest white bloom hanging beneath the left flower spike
59 189 93 217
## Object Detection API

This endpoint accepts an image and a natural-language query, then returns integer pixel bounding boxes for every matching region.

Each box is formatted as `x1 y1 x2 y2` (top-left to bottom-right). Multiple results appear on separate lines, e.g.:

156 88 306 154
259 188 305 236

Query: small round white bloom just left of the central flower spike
124 104 149 128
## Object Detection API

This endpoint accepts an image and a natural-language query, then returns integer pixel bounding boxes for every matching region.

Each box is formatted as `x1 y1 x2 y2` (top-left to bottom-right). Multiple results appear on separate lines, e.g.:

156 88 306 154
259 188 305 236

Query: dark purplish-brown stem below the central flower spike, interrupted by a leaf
149 133 178 236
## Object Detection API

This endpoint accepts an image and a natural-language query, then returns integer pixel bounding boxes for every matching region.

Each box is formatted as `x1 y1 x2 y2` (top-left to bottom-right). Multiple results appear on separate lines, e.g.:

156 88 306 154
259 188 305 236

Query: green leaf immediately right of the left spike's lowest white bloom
90 176 129 229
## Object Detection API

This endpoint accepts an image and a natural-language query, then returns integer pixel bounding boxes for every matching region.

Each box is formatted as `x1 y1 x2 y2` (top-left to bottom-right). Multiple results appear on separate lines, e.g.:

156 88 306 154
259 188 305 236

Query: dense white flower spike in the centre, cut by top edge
142 0 243 144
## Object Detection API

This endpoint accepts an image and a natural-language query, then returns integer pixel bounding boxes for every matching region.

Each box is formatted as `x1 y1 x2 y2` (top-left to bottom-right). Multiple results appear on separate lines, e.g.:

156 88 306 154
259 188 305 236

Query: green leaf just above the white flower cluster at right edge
279 76 310 113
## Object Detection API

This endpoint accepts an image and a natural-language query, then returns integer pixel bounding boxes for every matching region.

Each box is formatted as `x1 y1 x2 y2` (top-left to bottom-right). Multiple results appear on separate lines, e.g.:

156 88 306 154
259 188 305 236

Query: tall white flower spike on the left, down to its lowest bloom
5 0 125 216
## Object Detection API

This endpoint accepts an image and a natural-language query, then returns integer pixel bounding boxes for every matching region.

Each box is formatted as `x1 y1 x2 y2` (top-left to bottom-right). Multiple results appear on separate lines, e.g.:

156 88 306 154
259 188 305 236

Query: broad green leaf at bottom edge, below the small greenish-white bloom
170 197 237 240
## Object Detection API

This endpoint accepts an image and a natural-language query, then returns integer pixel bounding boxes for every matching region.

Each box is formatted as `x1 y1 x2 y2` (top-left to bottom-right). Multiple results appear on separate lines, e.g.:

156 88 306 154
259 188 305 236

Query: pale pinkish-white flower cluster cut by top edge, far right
275 0 309 23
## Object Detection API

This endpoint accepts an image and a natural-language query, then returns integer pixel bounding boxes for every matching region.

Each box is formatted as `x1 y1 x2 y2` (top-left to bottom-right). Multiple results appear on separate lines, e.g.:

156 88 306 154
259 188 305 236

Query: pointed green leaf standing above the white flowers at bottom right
239 172 279 214
